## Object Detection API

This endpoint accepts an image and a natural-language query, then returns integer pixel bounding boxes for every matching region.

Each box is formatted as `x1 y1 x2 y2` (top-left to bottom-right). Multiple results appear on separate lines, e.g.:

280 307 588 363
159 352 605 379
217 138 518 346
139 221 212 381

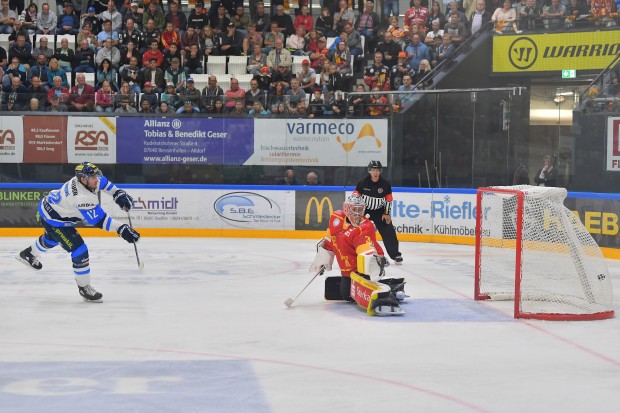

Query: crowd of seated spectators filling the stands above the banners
0 0 615 118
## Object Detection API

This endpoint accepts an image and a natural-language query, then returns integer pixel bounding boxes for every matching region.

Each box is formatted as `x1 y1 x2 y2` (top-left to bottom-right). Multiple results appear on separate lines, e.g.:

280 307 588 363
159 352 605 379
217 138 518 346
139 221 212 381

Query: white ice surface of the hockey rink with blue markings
0 237 620 413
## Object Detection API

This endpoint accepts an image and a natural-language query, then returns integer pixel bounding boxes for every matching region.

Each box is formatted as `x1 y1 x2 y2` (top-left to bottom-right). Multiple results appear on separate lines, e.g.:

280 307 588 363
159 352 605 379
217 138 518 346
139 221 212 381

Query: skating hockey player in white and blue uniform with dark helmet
16 162 140 303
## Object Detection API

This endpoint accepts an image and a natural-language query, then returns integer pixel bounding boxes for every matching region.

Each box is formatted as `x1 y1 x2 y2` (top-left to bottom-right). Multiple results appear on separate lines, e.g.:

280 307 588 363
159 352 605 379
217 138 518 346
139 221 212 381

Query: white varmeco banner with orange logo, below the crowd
245 119 388 166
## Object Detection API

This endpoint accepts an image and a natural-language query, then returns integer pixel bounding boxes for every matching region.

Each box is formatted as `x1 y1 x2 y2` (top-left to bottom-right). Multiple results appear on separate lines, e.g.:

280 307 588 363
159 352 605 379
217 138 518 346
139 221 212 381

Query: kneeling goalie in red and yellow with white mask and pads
310 194 407 316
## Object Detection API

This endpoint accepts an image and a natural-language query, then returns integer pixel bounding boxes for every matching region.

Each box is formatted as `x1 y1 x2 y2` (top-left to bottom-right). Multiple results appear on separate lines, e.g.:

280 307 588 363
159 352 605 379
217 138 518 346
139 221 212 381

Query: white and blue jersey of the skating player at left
39 176 121 231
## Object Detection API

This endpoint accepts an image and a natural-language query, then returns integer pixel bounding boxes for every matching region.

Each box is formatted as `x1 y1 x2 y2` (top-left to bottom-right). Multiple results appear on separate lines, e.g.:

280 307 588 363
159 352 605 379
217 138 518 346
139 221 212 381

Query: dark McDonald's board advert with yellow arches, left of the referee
295 191 345 230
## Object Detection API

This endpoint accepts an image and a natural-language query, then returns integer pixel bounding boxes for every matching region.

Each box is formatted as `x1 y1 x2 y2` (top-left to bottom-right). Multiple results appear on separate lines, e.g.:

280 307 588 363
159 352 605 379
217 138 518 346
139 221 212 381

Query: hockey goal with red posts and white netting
474 185 614 320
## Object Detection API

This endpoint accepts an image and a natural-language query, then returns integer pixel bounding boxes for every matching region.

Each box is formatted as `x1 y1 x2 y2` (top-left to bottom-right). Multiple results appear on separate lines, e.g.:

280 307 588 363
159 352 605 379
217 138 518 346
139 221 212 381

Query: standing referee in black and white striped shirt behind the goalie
353 161 403 265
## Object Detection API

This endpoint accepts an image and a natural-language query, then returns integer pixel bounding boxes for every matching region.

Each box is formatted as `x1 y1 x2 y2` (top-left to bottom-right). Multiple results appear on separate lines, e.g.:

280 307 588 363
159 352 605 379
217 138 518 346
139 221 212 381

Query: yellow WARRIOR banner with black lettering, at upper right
492 30 620 74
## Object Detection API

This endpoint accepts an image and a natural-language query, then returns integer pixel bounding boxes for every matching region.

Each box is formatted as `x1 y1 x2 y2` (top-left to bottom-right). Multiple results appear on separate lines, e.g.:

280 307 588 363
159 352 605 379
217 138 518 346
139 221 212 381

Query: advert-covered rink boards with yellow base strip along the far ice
0 183 620 258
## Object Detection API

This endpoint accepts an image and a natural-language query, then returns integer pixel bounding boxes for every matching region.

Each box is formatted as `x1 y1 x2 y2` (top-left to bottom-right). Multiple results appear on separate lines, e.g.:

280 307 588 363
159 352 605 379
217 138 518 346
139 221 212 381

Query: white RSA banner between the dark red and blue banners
67 116 116 164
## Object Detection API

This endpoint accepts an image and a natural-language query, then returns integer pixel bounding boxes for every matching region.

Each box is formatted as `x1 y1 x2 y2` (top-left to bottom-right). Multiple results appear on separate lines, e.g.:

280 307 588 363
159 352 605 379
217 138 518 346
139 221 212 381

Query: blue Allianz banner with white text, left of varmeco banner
116 117 254 165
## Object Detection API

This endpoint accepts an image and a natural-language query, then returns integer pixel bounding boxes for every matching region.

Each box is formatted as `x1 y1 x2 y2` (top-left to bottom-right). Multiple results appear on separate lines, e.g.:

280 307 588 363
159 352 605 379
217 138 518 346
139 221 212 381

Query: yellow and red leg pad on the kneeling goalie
351 272 405 316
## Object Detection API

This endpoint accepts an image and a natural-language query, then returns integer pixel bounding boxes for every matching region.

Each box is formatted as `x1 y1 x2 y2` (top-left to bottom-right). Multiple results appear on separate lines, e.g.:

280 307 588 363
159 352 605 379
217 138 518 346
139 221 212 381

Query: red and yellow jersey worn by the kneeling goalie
324 210 384 277
